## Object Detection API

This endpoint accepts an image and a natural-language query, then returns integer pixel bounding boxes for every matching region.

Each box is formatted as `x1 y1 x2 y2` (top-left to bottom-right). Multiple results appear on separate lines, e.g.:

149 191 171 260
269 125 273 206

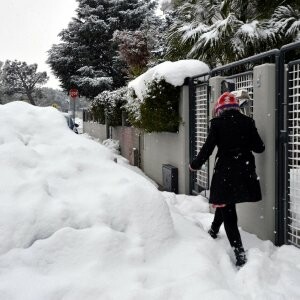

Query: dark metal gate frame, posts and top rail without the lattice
189 48 300 246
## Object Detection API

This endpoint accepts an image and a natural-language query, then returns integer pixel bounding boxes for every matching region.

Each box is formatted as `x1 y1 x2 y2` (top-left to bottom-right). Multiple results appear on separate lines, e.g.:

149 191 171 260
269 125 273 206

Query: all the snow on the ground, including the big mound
0 102 300 300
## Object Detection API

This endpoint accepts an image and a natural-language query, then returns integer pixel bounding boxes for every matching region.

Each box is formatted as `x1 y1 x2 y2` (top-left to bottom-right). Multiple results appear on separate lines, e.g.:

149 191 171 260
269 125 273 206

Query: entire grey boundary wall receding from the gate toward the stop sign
83 86 190 194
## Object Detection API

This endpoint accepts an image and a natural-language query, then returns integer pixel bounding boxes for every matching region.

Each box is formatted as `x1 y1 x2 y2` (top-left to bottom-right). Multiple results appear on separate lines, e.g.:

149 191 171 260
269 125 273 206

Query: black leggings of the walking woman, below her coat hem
211 204 243 248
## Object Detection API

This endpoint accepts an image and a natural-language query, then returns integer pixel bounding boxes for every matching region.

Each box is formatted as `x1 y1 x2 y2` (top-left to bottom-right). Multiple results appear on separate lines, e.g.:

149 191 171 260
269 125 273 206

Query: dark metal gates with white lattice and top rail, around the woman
189 42 300 247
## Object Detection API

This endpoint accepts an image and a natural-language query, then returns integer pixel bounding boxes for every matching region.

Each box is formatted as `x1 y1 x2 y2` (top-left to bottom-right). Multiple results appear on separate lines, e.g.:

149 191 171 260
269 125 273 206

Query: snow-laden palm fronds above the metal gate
167 0 299 67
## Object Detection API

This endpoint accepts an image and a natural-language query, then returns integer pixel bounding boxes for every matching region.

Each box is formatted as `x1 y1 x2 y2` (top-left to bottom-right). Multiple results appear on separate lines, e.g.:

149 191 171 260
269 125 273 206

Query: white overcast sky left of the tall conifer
0 0 77 88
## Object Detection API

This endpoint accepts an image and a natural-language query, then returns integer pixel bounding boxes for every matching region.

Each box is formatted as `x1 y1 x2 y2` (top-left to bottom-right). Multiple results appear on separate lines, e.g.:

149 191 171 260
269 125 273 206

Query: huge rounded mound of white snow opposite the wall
0 102 174 299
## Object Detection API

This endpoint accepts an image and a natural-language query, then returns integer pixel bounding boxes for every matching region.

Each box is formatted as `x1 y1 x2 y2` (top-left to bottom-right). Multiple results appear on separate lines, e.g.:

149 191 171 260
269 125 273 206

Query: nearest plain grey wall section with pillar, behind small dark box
141 86 189 194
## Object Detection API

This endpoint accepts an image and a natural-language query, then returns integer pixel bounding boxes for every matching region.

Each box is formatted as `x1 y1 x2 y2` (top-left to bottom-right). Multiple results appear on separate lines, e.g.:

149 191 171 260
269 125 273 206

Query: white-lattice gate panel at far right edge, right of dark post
286 60 300 247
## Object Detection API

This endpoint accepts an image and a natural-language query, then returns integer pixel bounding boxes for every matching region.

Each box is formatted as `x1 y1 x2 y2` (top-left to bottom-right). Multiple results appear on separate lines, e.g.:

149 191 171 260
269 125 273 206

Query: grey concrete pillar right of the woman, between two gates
237 64 276 242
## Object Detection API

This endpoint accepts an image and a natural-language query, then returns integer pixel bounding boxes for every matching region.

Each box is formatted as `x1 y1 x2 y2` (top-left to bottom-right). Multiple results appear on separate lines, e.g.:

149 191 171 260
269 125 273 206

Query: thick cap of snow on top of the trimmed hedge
128 59 209 100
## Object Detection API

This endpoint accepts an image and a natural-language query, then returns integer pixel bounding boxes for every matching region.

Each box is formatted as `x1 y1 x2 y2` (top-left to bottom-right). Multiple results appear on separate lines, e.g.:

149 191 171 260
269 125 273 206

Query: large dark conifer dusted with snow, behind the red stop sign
48 0 155 98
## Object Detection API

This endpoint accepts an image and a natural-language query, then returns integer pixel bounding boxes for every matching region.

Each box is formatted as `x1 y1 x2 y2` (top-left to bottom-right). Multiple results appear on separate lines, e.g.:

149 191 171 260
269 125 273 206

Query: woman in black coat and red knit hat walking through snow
190 92 265 266
